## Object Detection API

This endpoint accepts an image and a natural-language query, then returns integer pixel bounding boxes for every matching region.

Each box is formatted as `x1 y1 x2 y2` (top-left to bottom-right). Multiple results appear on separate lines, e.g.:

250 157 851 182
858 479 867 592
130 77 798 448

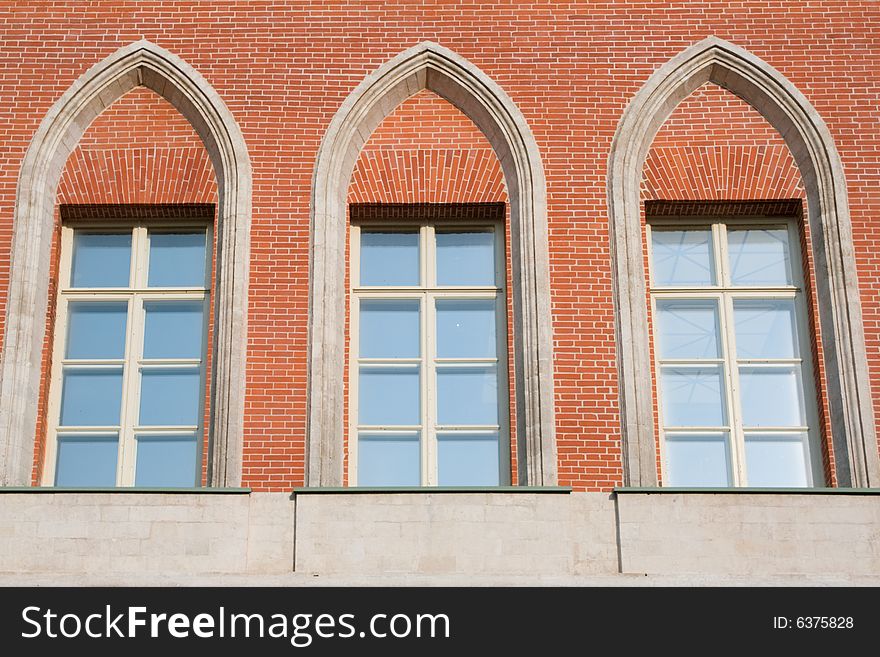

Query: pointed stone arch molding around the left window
0 40 252 486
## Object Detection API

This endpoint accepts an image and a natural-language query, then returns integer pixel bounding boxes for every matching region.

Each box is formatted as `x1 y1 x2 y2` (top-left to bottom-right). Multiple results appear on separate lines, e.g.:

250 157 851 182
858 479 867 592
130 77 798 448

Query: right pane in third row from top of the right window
739 367 806 427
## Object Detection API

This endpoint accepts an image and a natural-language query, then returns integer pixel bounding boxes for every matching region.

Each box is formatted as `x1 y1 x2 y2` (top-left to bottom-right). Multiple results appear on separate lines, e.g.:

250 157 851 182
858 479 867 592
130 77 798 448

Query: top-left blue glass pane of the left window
70 232 131 287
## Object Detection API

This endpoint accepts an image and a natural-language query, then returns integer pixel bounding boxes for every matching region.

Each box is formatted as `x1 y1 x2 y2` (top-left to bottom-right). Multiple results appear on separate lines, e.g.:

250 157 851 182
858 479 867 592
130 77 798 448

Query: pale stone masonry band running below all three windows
0 489 880 586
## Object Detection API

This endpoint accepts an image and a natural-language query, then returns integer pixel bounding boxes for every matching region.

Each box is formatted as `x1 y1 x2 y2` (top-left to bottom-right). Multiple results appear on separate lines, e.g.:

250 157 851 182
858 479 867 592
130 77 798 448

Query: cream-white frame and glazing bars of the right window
646 217 825 487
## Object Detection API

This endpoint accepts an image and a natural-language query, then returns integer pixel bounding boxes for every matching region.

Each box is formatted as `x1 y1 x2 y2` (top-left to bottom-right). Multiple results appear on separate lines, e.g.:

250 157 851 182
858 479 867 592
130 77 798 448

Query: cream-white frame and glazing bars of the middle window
348 221 511 486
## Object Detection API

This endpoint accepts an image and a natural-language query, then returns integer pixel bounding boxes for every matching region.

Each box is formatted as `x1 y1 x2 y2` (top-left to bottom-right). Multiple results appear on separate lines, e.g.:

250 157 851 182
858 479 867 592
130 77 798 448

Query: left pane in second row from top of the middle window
359 299 421 358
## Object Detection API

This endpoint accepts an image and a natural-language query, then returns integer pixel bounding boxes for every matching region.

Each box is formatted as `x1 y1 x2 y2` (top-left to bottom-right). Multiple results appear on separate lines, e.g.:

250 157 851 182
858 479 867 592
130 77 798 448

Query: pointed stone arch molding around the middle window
306 42 556 486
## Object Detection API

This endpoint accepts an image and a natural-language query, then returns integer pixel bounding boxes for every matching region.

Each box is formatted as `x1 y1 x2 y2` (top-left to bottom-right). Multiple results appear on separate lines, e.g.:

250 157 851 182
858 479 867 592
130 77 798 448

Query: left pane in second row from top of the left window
65 302 128 358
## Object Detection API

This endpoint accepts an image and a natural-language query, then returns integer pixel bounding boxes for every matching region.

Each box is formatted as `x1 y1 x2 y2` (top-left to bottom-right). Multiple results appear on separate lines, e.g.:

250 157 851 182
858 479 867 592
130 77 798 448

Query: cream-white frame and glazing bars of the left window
41 220 213 487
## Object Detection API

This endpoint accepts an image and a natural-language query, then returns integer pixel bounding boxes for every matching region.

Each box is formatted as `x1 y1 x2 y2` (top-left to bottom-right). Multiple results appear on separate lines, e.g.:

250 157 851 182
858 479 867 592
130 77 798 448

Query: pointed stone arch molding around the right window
608 37 880 487
